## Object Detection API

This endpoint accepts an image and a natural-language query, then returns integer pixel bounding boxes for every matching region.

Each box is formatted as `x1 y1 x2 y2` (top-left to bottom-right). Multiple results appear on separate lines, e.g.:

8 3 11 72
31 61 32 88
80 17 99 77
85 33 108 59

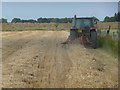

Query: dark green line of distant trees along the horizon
0 12 120 23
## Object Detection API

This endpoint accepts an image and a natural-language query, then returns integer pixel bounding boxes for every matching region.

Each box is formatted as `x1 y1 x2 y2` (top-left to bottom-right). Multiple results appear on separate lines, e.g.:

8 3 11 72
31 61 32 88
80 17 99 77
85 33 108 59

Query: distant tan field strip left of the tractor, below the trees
2 23 71 31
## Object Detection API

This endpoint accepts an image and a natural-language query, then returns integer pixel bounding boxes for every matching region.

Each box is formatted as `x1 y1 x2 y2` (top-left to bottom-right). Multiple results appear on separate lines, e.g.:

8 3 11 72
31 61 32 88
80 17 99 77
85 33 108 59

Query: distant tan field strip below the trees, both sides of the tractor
2 22 120 31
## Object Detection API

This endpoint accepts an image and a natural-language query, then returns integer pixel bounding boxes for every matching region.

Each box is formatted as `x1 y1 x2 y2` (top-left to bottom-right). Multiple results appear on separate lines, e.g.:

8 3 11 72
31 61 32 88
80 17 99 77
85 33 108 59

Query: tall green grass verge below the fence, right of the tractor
98 36 120 58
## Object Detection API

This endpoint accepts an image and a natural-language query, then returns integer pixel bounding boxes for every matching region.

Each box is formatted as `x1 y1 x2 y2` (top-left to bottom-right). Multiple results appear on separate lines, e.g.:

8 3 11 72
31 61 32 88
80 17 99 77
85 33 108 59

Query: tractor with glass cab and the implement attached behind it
63 15 98 49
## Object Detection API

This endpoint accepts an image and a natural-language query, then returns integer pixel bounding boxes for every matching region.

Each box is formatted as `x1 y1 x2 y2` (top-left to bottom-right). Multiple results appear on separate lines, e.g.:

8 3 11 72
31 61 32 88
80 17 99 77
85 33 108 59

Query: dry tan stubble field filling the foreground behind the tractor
2 31 118 88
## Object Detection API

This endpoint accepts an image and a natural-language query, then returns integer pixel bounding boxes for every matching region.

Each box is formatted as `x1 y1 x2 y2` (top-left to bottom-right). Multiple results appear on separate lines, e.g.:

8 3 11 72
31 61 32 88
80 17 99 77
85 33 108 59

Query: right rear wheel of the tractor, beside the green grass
90 31 97 49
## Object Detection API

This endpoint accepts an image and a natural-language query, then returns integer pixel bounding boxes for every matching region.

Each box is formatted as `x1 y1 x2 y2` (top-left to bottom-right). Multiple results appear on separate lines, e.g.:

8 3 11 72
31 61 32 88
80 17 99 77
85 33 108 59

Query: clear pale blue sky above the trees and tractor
2 2 118 21
